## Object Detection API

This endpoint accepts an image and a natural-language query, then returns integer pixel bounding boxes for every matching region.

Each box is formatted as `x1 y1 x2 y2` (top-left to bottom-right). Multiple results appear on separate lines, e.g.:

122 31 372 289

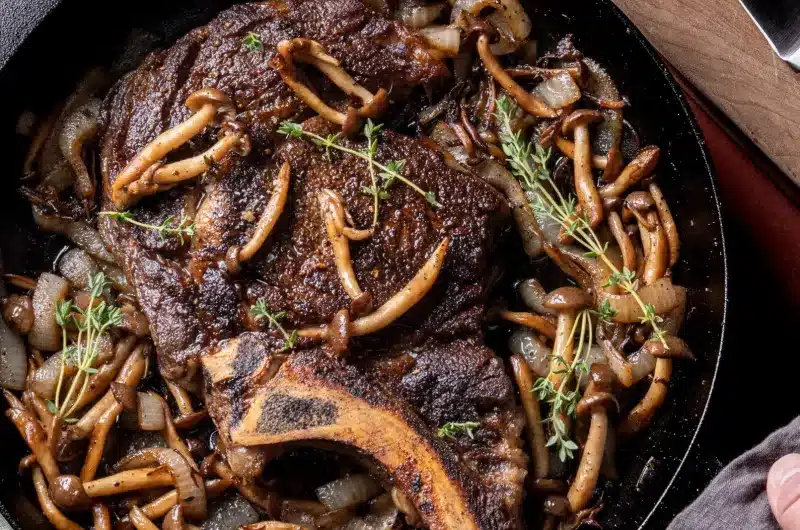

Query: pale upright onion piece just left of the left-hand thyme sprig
28 272 69 351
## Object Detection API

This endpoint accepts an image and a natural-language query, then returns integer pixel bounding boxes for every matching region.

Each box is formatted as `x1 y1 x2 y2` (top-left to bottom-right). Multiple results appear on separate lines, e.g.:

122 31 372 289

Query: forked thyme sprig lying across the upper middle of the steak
278 121 442 208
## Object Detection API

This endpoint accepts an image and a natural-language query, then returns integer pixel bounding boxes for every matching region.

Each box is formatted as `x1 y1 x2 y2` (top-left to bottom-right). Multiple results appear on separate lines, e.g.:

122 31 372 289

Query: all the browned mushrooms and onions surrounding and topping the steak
0 0 692 530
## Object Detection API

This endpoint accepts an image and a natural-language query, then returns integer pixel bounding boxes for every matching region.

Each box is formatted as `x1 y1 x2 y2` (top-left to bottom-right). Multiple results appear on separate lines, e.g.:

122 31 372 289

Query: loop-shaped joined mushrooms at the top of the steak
269 38 388 134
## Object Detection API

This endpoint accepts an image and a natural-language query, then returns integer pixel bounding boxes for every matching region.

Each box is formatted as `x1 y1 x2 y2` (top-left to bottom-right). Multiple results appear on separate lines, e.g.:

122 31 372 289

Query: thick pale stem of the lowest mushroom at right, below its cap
567 407 608 513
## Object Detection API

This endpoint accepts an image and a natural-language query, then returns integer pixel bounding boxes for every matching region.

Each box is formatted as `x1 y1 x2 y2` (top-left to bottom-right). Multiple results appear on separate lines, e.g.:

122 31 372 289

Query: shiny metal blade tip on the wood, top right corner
739 0 800 68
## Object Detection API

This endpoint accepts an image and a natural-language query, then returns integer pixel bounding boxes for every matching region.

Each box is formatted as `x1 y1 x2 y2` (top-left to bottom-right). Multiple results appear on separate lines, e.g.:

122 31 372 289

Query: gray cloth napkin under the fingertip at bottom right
668 418 800 530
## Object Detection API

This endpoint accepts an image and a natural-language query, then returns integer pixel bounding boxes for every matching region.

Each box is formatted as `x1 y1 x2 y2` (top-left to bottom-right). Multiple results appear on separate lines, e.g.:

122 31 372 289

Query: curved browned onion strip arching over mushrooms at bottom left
117 448 207 519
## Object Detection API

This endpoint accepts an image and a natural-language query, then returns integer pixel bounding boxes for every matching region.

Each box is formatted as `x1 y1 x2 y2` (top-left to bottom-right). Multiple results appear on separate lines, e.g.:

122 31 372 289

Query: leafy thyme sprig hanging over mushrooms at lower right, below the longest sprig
532 310 594 462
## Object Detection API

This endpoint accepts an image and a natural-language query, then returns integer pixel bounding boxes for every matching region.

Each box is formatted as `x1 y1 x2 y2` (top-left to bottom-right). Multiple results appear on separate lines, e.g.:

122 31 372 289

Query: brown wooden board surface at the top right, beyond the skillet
614 0 800 185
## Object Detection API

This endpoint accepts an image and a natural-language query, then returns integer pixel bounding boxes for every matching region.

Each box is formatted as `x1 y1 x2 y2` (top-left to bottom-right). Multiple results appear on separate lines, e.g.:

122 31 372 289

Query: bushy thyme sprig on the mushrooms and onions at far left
47 272 122 423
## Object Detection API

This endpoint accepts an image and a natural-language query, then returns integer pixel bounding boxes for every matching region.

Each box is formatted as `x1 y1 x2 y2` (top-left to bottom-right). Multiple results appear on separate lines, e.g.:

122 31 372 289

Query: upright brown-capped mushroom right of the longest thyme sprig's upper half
561 109 603 227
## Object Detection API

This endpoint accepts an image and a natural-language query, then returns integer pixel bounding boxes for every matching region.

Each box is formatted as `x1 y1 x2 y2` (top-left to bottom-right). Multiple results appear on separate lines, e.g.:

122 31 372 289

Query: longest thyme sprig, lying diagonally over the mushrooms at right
497 96 667 347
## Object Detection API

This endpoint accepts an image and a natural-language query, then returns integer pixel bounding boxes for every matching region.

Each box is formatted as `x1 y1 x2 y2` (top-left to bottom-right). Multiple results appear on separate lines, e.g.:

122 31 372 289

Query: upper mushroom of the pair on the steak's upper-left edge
111 88 241 209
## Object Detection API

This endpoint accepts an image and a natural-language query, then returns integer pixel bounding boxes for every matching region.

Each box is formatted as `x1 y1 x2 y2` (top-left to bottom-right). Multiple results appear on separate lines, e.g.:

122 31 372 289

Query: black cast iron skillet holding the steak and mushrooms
0 0 727 530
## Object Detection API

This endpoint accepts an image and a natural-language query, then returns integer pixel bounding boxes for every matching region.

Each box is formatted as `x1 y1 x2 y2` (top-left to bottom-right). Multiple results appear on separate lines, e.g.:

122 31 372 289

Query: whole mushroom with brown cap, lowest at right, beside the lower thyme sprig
567 364 614 513
